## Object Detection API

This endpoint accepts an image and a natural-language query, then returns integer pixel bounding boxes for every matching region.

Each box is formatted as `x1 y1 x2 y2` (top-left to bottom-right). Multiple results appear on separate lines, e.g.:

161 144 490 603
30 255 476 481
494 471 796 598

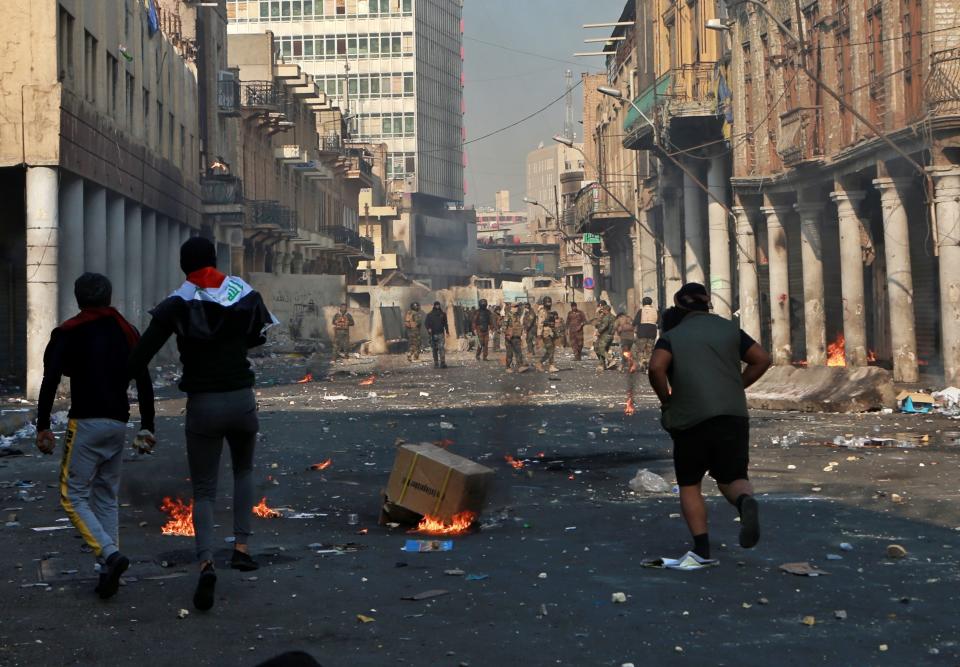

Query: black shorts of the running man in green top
670 415 750 486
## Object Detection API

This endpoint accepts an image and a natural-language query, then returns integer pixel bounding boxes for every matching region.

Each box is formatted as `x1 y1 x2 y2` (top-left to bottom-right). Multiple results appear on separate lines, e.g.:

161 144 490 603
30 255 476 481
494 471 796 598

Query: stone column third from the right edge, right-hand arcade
830 190 867 366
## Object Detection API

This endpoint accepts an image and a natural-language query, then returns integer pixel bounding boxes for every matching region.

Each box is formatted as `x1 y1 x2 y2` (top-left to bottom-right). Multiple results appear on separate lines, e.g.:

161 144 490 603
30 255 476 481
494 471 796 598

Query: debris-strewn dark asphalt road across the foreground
0 351 960 667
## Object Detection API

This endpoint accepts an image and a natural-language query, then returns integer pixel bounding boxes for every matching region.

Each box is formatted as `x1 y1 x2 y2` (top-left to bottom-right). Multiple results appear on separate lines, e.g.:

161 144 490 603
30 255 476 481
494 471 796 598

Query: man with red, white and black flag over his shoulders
130 237 277 610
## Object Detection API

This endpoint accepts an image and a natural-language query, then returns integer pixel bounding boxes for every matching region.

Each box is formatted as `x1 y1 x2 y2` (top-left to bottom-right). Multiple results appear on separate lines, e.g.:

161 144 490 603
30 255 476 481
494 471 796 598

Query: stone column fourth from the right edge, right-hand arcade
794 201 827 366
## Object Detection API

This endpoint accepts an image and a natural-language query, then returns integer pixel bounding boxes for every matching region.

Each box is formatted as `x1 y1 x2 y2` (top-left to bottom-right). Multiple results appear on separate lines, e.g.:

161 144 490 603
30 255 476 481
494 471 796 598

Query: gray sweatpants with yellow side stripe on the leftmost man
60 419 127 563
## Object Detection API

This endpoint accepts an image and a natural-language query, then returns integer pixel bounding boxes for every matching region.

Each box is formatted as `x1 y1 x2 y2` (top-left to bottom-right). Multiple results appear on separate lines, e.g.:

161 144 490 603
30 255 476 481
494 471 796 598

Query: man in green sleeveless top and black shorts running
649 283 770 558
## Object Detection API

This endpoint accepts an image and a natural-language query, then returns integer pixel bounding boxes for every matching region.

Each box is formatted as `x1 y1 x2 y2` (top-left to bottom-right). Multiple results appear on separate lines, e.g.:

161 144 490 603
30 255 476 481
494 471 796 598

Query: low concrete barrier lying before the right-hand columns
747 366 896 412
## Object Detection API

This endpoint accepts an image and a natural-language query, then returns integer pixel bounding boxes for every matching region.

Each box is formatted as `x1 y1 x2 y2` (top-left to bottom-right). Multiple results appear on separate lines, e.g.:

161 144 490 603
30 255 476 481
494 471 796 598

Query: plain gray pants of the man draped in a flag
186 389 260 561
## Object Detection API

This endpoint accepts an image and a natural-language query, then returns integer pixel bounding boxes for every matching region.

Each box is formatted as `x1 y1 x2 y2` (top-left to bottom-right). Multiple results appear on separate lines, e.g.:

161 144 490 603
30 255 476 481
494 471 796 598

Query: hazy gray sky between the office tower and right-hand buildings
463 0 625 210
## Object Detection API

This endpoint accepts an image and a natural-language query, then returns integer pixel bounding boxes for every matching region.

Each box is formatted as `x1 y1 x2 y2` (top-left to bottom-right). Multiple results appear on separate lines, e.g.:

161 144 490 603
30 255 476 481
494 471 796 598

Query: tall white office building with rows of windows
227 0 464 202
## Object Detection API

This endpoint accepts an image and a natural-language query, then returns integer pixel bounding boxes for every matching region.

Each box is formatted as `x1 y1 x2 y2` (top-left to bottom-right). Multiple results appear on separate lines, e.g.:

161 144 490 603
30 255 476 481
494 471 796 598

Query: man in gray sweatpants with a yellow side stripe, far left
37 273 156 599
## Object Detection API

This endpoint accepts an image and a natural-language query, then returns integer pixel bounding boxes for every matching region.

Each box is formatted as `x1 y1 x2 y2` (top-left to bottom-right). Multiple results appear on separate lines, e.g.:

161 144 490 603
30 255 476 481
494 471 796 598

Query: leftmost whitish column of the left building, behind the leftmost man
26 167 59 400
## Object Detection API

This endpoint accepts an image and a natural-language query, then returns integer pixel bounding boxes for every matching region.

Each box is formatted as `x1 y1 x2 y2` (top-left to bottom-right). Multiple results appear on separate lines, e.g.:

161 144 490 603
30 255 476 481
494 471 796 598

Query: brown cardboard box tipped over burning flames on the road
386 444 493 521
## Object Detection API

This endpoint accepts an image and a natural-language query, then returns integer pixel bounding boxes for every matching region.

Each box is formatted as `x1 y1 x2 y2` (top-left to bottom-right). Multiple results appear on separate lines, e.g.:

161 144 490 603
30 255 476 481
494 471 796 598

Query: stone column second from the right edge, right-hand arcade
873 178 920 382
